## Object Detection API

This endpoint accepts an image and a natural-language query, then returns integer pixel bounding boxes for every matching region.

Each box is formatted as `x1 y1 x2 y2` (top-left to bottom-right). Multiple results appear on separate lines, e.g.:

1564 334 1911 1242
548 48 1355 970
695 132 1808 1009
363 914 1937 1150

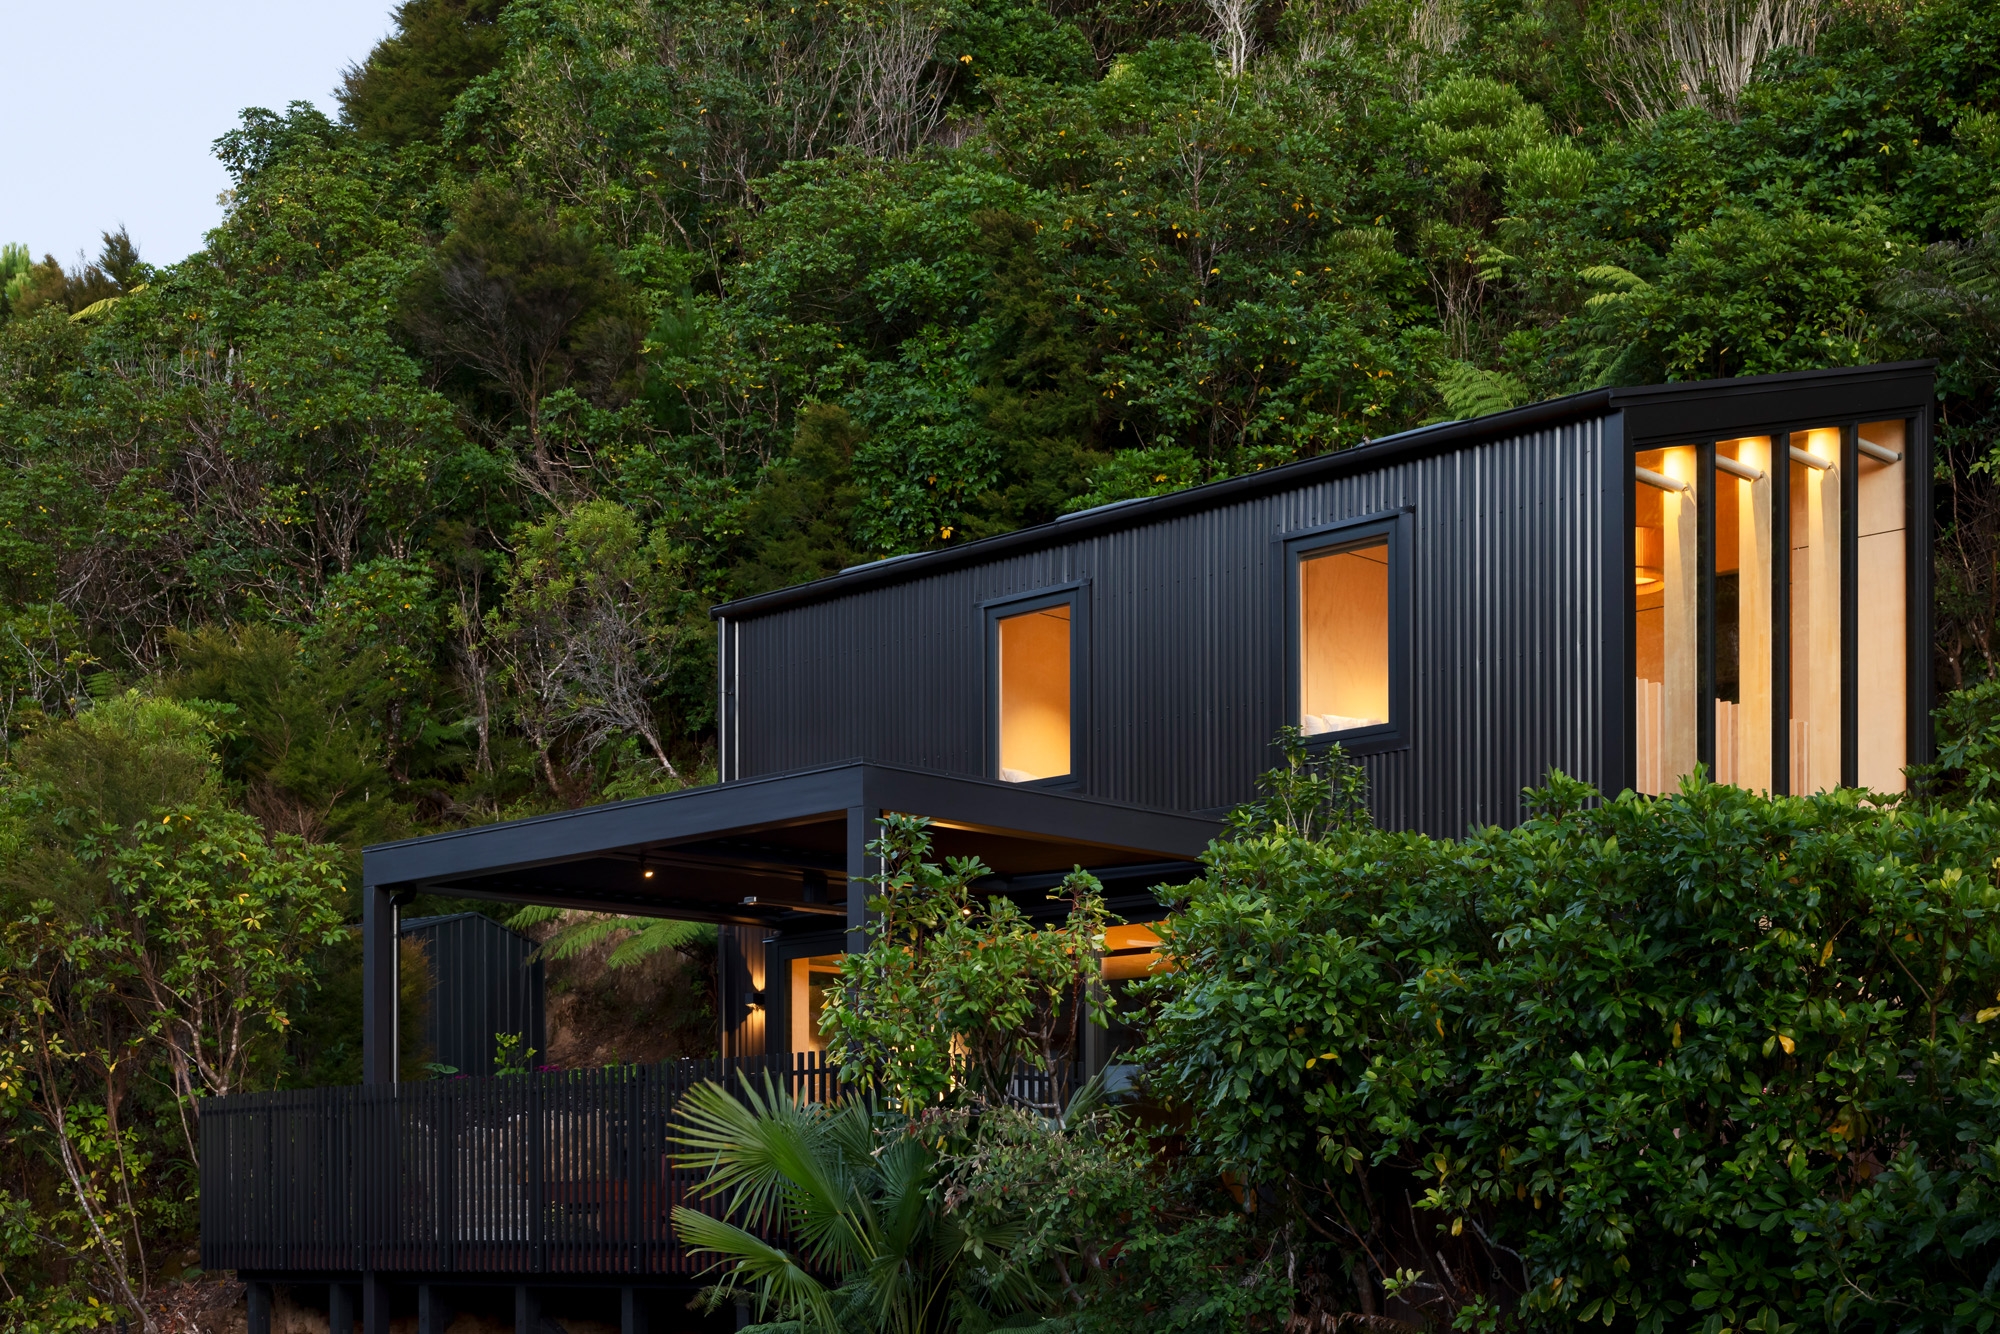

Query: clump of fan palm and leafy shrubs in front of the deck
674 816 1264 1334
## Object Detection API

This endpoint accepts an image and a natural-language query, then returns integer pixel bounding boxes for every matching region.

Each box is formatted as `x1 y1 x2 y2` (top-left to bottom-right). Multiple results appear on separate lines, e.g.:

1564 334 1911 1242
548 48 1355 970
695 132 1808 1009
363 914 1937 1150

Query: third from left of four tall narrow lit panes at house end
1788 426 1840 792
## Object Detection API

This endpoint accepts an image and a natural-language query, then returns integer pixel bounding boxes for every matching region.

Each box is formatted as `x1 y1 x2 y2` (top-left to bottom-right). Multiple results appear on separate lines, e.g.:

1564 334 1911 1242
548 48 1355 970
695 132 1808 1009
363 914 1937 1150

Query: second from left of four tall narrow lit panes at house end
1712 436 1774 792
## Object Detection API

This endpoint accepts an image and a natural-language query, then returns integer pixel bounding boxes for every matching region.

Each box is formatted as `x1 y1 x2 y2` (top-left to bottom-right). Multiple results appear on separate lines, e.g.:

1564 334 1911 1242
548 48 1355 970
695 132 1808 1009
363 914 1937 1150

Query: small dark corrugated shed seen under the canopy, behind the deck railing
402 912 548 1076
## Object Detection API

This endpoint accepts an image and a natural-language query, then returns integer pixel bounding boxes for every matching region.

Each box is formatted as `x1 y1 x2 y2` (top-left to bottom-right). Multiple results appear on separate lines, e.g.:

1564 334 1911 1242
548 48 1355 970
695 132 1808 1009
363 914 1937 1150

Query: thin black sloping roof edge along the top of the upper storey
708 360 1936 618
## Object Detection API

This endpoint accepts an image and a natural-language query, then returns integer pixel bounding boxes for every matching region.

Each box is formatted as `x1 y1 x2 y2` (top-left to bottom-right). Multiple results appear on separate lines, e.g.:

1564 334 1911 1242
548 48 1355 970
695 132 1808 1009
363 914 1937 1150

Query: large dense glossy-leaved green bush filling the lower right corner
1140 748 2000 1332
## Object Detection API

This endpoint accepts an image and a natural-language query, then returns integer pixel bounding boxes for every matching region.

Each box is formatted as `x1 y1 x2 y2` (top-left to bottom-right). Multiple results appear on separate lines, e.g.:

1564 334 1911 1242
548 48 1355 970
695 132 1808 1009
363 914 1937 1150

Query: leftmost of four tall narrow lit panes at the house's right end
1632 446 1700 792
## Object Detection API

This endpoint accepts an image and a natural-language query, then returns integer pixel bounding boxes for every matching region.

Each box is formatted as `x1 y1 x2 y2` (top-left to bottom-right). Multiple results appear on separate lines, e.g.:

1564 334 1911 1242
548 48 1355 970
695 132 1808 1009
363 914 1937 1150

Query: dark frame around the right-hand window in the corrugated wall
1272 510 1416 754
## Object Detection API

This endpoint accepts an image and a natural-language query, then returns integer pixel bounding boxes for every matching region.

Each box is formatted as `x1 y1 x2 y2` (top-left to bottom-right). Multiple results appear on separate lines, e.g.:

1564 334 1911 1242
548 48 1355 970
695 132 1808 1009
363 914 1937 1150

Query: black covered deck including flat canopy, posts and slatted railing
202 762 1220 1334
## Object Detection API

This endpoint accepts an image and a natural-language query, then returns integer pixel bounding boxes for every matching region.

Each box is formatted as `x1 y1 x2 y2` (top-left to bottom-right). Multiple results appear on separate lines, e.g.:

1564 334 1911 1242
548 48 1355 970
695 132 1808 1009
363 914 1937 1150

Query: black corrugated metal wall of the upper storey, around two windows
724 416 1622 834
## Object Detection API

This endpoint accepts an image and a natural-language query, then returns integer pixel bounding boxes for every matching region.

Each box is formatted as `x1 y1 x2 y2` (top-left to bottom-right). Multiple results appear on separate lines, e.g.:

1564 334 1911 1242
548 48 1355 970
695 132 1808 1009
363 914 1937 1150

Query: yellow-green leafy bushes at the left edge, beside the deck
0 694 342 1330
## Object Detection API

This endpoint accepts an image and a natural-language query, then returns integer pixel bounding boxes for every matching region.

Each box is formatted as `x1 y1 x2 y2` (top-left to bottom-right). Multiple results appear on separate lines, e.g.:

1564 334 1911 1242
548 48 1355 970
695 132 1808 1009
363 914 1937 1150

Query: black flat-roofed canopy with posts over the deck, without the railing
362 760 1220 1084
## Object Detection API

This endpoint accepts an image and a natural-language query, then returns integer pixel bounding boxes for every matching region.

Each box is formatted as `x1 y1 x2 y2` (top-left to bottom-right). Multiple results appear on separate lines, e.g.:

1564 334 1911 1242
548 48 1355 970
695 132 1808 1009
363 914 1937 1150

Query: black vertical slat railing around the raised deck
200 1052 1074 1276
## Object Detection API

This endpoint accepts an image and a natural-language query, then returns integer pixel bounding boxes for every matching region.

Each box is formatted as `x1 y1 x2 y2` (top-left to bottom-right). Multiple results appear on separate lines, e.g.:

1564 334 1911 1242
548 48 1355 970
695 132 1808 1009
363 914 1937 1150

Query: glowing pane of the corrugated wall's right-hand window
1298 538 1390 736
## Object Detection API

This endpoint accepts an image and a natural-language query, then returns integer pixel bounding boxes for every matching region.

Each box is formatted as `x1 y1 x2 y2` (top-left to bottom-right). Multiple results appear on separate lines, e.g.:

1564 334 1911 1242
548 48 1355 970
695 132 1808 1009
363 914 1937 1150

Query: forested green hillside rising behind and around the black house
0 0 2000 1334
